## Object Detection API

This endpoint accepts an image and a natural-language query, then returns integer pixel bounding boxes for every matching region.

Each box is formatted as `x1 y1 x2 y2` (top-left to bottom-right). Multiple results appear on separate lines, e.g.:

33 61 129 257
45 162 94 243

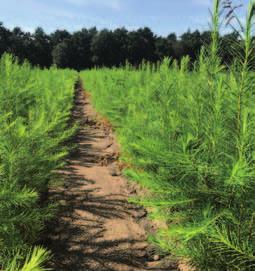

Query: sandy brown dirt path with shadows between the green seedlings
47 86 177 271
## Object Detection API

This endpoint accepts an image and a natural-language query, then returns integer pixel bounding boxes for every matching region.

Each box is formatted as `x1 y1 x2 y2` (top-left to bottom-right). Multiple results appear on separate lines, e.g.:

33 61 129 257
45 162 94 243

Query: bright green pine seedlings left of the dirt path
0 54 77 271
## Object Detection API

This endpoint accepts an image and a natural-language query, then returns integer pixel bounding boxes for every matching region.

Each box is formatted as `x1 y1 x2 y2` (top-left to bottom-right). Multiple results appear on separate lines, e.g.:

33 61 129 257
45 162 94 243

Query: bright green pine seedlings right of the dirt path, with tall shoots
82 0 255 271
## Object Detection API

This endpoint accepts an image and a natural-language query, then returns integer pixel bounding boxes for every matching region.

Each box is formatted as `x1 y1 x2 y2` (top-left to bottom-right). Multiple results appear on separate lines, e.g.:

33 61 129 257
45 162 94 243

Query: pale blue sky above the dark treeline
0 0 248 36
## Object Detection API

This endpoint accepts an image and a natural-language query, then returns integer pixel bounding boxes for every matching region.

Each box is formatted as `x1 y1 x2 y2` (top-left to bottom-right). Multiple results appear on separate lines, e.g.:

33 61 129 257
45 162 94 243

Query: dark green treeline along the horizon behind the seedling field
0 23 238 70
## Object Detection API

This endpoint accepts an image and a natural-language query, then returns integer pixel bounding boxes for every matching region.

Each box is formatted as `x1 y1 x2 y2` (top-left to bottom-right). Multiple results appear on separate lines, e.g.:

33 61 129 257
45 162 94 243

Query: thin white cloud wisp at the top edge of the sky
65 0 121 10
